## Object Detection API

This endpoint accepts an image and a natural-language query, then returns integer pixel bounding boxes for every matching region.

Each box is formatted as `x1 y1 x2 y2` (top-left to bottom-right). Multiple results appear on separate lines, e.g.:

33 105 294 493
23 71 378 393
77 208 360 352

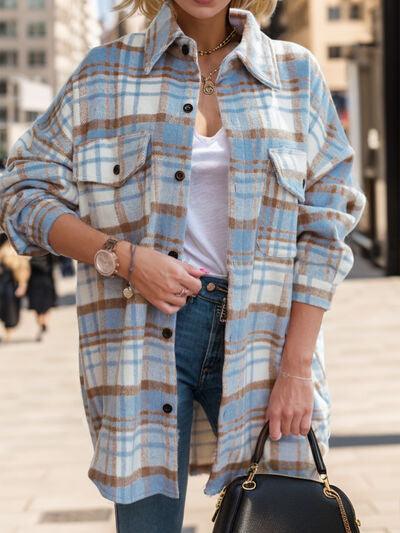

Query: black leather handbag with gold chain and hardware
211 421 361 533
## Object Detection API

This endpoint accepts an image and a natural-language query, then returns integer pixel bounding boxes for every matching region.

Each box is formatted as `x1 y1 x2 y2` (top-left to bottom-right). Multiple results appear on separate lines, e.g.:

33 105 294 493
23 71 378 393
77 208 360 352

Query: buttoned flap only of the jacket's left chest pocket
74 131 150 187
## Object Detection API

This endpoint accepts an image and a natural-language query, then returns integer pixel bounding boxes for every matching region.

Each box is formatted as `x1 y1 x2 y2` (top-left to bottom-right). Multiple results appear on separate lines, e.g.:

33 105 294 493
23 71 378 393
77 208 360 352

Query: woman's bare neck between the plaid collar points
174 3 233 50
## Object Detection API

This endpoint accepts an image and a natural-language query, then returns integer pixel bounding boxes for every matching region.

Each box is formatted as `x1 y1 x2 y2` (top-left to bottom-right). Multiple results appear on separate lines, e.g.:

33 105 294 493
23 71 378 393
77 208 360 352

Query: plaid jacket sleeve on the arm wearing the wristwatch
0 69 78 256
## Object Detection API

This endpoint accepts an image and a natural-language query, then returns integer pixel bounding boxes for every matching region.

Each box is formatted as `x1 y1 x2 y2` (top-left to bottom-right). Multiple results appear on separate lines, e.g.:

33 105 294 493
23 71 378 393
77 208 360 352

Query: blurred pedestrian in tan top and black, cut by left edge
0 234 30 342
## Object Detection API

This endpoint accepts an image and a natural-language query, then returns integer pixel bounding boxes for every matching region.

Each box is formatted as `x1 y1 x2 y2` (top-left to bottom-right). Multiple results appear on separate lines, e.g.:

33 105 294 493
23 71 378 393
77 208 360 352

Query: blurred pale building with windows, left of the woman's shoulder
0 0 101 159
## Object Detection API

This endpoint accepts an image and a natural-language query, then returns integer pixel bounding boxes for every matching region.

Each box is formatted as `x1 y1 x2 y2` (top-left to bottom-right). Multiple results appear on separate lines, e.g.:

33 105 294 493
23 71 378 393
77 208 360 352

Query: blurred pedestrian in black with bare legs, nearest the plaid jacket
27 254 57 341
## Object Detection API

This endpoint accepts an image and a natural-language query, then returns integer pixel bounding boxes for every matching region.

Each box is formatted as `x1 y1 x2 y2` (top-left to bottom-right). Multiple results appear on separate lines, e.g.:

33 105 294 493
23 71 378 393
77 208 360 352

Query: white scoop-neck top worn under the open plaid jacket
183 127 230 278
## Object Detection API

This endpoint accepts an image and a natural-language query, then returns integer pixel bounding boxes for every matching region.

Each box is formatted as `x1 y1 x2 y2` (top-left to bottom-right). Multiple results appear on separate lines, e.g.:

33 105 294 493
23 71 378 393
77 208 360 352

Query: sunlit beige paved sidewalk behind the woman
0 268 400 533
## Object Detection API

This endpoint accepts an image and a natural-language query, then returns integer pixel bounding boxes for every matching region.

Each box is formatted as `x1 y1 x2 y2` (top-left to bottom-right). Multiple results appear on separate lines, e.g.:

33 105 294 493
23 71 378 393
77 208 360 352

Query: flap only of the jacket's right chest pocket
269 148 307 202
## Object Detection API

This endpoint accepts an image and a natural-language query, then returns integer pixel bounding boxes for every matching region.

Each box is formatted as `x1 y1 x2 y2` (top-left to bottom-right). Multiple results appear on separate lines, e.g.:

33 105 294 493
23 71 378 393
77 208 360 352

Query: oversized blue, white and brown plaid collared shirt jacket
0 1 365 503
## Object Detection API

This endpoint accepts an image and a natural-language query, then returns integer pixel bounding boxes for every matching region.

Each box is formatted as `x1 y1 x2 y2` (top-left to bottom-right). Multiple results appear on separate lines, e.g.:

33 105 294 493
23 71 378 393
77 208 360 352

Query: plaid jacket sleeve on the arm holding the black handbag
292 52 366 310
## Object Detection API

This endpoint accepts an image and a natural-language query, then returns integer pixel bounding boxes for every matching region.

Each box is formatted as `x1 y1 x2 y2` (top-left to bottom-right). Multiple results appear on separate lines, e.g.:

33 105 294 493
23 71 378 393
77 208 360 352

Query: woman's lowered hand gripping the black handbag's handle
265 369 314 440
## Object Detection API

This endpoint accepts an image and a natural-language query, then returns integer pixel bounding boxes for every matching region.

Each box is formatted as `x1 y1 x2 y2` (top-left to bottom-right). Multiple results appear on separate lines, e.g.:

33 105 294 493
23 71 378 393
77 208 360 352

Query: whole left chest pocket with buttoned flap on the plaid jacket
74 131 151 236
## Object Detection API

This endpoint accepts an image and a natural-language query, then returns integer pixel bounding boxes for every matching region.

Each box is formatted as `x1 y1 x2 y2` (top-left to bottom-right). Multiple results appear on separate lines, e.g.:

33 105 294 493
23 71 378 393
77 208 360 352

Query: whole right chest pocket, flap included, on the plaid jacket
255 147 307 258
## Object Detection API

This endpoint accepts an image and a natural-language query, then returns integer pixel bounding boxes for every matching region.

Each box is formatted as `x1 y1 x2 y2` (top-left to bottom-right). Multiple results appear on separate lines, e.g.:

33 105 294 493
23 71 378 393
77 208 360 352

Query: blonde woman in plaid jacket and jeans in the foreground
0 0 365 533
